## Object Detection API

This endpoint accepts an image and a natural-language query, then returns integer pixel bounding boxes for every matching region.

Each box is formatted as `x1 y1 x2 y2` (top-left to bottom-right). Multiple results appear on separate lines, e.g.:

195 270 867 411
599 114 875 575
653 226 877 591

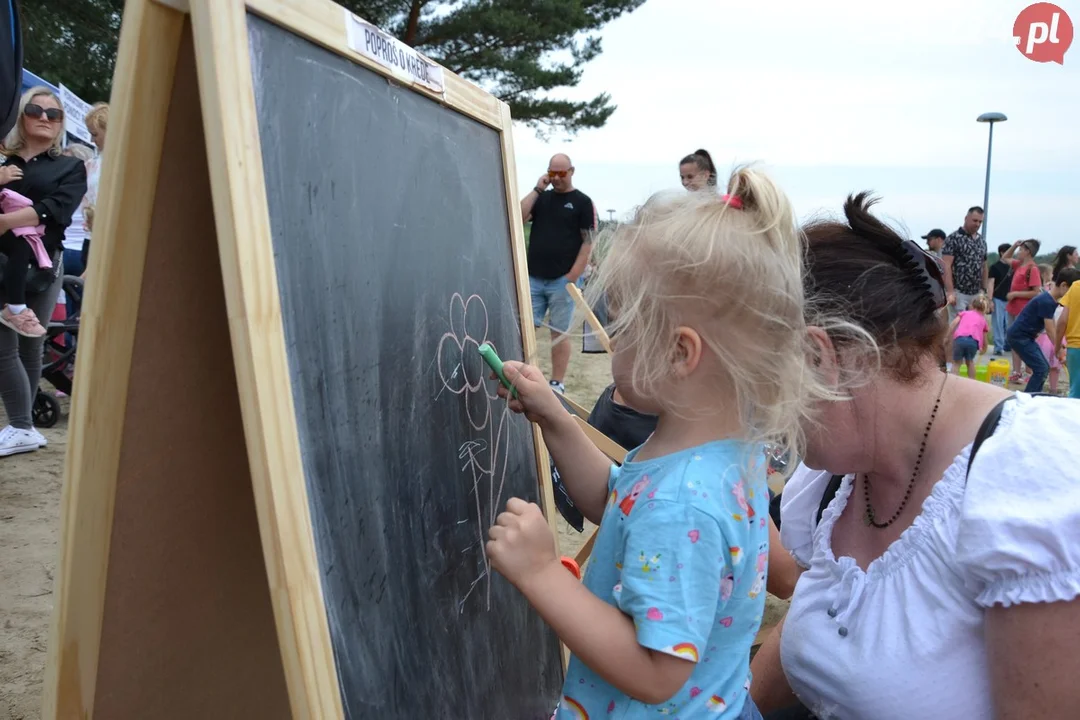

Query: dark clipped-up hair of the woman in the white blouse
802 192 946 381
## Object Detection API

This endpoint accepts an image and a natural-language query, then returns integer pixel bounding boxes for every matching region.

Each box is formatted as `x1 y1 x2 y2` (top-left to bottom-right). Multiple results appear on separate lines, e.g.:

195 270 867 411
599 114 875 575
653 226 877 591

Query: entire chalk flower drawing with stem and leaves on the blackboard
434 293 511 612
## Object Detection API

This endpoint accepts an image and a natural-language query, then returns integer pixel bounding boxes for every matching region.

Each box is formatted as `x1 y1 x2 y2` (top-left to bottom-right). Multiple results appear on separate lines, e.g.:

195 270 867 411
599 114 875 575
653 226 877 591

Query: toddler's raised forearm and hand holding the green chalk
499 361 611 525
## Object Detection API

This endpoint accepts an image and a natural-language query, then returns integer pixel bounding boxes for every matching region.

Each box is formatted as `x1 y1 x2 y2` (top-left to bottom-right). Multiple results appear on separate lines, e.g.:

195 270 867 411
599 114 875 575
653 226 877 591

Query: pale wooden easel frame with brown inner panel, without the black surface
42 0 566 720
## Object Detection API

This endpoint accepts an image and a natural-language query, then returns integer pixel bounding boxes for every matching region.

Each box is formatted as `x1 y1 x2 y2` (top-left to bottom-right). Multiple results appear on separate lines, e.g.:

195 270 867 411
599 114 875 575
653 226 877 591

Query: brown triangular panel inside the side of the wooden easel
94 27 291 720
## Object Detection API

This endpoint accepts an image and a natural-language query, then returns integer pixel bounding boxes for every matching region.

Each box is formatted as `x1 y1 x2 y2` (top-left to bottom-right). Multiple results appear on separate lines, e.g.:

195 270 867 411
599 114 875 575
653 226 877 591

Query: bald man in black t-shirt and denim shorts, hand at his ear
522 154 596 391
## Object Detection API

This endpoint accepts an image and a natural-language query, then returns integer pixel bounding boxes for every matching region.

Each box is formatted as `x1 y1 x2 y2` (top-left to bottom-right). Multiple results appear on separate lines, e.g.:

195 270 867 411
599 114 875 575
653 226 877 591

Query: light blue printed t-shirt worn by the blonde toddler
556 440 769 720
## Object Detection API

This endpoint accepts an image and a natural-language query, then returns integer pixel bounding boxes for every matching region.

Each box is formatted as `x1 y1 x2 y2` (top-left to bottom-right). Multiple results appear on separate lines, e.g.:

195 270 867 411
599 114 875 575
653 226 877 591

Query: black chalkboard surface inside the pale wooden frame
247 15 563 720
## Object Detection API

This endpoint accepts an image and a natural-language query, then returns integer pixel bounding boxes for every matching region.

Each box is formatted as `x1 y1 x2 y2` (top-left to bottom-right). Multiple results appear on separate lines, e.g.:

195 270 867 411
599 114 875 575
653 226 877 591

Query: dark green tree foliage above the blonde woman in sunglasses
19 0 124 103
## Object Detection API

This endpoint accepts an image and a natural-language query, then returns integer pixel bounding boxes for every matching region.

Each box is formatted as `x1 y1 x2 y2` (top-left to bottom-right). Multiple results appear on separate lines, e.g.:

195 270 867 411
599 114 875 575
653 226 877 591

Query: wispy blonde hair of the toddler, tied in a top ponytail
588 166 831 464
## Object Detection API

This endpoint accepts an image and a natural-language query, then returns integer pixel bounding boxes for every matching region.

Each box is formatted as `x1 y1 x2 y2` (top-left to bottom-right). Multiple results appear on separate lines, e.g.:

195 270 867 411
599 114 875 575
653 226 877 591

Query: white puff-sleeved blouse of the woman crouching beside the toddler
781 394 1080 720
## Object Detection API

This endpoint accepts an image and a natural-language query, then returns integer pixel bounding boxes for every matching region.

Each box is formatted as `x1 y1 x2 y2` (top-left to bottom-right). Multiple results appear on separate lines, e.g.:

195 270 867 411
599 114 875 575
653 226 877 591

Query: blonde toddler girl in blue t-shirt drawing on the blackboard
487 168 822 720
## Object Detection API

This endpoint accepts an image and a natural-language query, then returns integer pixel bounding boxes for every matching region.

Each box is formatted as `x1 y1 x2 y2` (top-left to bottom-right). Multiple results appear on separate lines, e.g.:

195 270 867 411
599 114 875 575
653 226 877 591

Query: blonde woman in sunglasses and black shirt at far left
0 87 86 457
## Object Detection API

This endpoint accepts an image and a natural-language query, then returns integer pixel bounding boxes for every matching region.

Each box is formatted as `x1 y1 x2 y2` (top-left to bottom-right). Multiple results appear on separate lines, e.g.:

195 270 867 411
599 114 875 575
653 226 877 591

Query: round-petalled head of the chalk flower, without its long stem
437 293 498 430
